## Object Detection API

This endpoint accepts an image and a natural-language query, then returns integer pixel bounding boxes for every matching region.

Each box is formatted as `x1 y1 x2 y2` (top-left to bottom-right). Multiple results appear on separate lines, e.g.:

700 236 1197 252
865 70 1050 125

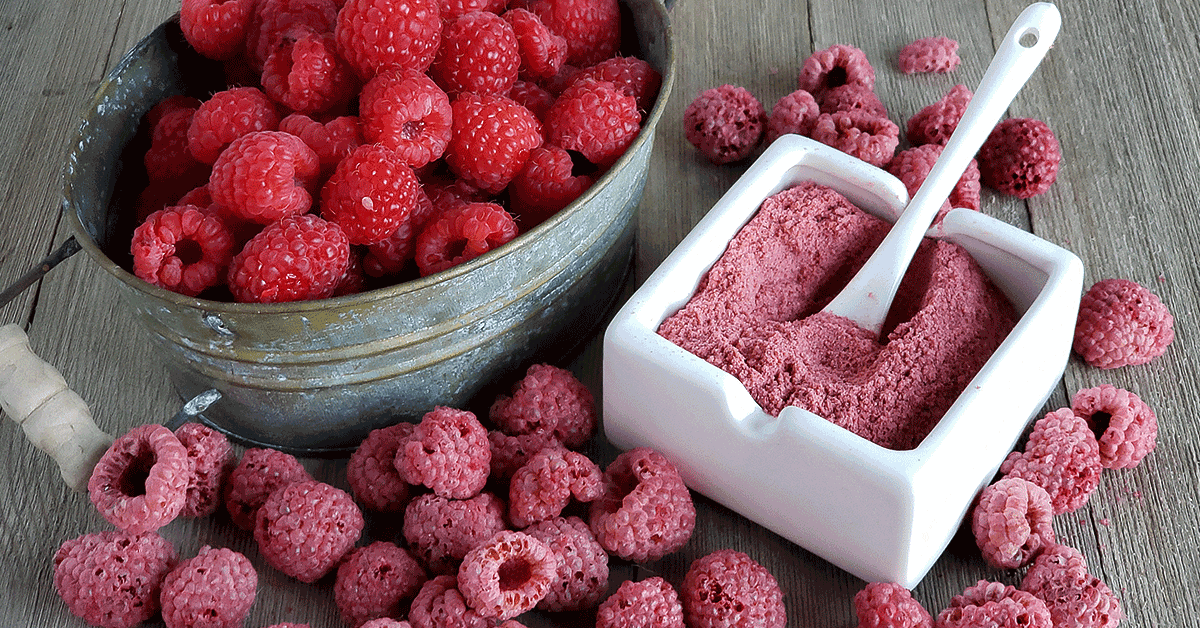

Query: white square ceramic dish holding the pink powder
604 136 1082 588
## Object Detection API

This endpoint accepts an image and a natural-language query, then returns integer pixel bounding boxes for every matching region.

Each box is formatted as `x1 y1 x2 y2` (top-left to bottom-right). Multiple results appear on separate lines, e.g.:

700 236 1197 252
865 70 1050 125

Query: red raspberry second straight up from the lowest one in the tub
187 88 280 163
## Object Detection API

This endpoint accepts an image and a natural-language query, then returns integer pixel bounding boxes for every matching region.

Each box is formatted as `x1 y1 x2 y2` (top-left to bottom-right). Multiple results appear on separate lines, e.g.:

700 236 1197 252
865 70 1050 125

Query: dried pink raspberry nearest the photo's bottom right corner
1021 545 1124 628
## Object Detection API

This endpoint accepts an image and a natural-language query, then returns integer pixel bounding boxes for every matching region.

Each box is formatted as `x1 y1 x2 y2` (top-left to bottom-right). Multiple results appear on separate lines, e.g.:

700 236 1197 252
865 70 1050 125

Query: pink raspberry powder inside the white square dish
659 183 1016 449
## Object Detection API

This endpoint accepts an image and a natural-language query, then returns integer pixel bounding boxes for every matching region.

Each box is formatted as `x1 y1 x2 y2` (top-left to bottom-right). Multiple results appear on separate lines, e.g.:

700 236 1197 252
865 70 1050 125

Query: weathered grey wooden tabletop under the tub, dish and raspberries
0 0 1200 628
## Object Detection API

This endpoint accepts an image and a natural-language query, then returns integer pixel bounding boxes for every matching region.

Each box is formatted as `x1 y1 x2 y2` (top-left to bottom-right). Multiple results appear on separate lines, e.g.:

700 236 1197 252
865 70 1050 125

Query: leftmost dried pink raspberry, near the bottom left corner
54 530 176 628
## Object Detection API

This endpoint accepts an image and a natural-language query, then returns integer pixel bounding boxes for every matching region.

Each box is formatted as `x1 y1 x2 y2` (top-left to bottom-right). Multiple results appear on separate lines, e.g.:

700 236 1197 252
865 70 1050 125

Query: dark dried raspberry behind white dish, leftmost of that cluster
683 85 767 165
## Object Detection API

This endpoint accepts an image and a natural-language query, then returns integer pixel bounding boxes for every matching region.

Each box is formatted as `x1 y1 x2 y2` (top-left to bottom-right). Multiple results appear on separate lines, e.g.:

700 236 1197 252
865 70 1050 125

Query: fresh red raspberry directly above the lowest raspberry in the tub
209 131 320 225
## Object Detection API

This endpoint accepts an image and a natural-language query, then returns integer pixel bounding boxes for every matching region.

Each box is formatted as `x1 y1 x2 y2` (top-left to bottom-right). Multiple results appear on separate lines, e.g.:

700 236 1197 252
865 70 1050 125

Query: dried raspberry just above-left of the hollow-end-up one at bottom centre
404 492 508 574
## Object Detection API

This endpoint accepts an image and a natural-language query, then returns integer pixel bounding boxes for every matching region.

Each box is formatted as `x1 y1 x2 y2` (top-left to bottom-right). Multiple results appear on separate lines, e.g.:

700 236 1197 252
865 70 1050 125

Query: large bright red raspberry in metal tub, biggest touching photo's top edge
334 0 442 80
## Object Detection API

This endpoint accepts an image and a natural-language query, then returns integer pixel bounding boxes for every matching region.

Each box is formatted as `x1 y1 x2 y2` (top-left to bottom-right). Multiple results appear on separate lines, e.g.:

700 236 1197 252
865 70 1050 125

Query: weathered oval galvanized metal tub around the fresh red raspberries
64 0 674 453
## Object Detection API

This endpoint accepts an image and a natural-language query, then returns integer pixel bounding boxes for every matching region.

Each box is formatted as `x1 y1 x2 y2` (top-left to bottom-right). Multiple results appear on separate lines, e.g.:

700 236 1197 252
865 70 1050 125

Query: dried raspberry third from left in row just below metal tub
224 448 312 530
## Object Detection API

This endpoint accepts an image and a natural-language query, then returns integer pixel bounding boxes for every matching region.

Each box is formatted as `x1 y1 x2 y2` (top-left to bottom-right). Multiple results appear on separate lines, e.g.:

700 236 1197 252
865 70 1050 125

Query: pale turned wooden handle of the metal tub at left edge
0 324 113 491
